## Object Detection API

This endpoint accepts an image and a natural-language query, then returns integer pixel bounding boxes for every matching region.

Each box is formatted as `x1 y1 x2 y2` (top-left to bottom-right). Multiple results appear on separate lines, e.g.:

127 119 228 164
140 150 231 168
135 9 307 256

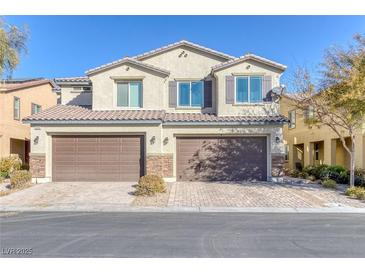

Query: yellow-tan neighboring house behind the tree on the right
280 95 365 170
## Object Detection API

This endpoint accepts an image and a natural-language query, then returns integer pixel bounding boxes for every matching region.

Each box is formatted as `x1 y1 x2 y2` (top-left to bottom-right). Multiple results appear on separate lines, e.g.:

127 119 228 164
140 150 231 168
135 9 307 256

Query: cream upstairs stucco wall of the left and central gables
90 47 229 112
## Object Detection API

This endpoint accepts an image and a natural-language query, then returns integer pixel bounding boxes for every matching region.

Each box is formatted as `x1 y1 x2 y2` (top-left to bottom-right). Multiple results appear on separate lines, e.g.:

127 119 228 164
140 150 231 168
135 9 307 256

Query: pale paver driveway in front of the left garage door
0 182 135 210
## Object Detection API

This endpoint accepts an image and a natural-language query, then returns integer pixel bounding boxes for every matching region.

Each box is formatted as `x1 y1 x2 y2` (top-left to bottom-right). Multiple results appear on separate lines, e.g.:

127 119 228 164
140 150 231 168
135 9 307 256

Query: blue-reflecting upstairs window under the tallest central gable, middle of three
177 81 204 107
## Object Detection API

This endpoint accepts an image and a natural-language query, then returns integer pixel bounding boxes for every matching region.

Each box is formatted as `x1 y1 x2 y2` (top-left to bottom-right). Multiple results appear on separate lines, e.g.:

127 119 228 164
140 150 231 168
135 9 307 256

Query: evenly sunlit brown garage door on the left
52 136 144 182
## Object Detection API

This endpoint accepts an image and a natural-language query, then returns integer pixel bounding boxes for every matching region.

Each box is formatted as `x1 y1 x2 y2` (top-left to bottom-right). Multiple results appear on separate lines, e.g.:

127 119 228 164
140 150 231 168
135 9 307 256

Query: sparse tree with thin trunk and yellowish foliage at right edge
293 34 365 186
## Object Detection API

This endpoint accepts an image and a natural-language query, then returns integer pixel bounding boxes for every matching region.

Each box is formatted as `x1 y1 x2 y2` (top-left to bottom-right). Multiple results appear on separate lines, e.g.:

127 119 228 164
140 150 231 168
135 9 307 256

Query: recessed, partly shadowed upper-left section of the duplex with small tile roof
54 77 92 108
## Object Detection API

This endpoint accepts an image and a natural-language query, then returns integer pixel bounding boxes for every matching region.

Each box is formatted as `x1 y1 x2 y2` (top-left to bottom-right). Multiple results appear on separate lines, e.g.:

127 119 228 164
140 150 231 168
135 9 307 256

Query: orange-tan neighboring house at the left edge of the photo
0 79 57 163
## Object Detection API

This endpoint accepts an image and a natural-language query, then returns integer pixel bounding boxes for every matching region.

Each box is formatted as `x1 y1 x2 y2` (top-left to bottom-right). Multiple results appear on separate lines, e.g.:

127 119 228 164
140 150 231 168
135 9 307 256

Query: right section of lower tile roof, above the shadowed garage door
164 113 287 123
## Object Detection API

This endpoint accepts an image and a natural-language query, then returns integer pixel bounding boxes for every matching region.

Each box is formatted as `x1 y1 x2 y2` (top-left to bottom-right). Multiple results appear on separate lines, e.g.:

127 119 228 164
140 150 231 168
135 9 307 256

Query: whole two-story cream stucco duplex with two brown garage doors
24 41 287 182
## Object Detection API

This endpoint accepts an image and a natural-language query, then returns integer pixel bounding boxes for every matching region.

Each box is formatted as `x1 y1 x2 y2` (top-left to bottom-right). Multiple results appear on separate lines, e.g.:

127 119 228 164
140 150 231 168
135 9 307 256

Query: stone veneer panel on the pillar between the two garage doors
146 153 173 177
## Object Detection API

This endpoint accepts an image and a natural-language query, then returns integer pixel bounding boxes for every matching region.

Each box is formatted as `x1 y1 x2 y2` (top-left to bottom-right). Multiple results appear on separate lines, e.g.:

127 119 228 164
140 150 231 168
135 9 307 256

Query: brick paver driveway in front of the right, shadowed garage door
167 181 365 208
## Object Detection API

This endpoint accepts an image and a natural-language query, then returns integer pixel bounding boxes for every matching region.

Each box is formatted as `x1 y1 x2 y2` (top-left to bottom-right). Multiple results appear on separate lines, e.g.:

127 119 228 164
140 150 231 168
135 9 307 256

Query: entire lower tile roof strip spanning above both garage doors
23 105 287 123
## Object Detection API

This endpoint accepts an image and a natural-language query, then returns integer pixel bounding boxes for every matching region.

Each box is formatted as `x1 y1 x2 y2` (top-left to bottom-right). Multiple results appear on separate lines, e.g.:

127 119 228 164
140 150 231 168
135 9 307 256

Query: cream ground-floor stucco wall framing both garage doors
31 124 283 180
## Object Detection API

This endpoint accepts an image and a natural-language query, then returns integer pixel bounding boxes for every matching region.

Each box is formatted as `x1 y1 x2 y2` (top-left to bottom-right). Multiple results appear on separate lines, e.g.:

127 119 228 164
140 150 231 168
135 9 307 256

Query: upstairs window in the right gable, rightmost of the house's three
235 76 262 104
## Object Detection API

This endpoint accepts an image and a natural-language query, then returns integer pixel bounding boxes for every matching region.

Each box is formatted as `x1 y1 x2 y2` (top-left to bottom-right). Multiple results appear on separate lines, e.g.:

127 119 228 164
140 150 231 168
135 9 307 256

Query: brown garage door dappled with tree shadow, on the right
176 137 267 181
